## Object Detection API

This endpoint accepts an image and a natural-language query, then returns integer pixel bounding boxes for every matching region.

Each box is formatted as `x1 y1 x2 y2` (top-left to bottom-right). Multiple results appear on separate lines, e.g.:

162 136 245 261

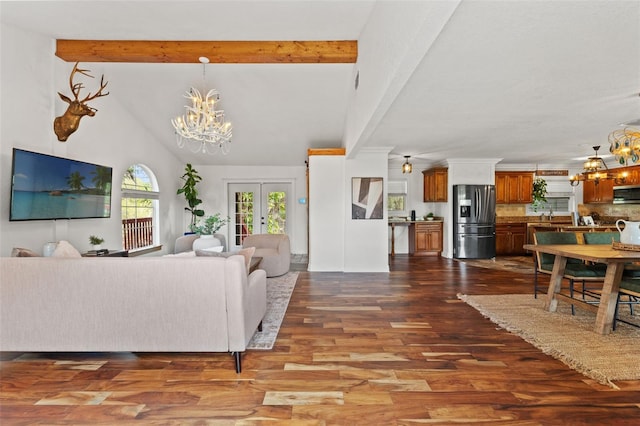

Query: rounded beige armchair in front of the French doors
242 234 291 277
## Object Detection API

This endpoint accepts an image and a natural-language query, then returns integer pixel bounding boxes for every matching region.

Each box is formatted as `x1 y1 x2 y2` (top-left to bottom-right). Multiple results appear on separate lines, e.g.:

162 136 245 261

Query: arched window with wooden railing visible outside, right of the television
122 164 160 251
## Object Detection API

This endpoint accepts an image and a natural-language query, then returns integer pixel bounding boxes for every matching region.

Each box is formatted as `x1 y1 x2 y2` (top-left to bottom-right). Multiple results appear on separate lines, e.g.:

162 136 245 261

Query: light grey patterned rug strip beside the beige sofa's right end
247 272 298 350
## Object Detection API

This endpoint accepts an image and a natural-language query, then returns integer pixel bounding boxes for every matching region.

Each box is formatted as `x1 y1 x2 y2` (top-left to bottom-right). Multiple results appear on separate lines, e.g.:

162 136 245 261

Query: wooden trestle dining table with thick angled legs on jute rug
523 244 640 334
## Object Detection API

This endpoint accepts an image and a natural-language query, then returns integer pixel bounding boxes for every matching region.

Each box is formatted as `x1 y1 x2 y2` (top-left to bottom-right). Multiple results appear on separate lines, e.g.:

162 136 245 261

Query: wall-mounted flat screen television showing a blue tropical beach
9 148 112 221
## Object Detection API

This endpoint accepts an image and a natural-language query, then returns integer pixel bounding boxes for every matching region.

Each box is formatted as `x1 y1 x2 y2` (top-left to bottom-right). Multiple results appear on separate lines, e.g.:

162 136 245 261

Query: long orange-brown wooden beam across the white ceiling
56 40 358 64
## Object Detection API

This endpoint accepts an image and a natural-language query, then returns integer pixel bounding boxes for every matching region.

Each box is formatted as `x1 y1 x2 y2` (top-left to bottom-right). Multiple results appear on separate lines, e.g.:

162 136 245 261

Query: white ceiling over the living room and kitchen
0 0 640 170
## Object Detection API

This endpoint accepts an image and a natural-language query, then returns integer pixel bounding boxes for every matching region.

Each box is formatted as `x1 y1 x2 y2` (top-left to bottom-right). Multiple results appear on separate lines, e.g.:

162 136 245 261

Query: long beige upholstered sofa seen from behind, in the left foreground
0 255 267 372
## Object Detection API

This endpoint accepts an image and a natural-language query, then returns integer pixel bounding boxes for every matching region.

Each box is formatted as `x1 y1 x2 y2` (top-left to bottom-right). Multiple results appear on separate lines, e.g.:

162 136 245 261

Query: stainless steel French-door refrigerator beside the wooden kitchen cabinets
453 185 496 259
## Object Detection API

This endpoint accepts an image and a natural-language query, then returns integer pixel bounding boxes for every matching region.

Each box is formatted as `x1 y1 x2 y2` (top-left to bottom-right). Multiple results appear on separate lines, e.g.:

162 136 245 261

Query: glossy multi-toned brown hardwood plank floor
0 255 640 425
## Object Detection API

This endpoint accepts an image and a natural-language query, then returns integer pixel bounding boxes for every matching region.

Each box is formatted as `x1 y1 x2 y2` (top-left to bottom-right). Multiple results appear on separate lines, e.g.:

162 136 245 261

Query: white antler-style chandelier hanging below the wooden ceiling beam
171 56 232 155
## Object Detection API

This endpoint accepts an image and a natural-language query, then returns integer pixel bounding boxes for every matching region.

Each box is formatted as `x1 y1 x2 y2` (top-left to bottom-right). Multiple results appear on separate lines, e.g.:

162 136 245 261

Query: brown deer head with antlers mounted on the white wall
53 62 109 142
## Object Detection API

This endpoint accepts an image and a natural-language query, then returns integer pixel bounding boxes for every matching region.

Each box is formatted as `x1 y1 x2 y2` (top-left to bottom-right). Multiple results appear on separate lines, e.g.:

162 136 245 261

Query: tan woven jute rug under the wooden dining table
458 294 640 388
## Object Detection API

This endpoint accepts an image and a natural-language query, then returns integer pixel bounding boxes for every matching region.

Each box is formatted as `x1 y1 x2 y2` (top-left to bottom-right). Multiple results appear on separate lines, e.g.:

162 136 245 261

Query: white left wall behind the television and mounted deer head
0 24 183 256
